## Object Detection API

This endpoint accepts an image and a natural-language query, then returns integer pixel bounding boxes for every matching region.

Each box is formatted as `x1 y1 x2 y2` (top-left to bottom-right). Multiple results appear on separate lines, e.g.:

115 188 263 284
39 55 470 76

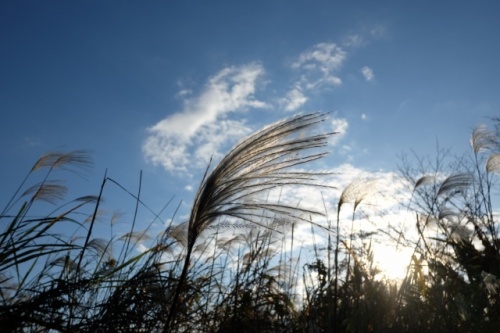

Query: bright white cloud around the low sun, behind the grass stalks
231 164 418 278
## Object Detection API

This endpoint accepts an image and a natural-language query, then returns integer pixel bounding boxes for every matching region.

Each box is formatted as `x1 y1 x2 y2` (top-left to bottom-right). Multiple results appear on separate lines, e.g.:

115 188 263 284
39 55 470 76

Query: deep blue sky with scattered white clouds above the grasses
0 0 500 280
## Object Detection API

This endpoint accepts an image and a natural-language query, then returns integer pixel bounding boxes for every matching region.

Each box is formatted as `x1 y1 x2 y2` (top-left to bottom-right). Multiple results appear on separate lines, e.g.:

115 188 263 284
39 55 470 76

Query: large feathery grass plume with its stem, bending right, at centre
165 113 334 332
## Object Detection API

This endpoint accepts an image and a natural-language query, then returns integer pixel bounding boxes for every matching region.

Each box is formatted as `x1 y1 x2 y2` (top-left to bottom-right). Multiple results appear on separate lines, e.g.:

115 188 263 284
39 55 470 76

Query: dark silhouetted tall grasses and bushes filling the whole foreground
0 114 500 333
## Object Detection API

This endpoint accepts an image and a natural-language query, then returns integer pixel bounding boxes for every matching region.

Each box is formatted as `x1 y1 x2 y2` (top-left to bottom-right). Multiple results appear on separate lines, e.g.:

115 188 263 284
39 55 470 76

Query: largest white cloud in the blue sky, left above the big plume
142 63 266 171
